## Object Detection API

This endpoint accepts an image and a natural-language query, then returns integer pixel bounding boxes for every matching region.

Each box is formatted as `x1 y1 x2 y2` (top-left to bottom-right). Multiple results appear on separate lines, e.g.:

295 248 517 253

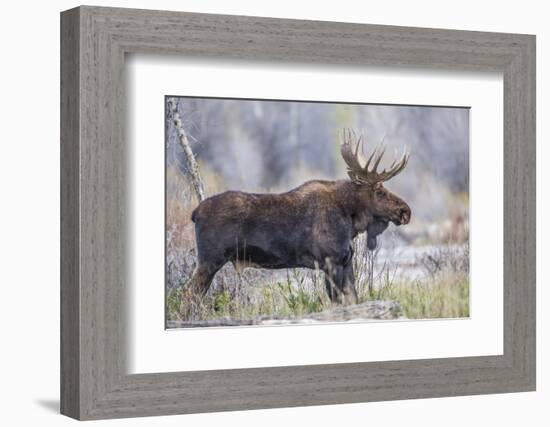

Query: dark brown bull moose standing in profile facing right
183 130 411 310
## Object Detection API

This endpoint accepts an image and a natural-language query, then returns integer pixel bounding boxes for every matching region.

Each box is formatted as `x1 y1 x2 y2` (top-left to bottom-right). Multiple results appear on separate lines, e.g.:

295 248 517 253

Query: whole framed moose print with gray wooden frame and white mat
61 6 535 419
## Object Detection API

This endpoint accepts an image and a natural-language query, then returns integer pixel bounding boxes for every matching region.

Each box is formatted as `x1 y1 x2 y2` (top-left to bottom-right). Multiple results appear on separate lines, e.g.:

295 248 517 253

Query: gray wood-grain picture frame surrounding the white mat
61 6 535 419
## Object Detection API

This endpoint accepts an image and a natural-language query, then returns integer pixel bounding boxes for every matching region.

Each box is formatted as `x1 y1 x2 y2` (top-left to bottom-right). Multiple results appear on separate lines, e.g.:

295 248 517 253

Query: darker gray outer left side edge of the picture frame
60 10 80 417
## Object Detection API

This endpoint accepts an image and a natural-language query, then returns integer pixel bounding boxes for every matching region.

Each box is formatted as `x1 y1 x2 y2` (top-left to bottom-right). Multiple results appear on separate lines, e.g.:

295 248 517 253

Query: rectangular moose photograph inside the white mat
165 95 470 329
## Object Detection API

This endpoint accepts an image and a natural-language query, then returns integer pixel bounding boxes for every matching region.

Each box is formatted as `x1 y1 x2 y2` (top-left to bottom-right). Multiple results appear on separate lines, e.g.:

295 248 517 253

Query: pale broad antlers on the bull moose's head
340 129 409 185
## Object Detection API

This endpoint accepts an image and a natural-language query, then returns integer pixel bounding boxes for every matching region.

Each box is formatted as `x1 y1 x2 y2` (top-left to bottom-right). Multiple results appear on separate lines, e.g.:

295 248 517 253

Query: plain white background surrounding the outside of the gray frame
0 0 550 427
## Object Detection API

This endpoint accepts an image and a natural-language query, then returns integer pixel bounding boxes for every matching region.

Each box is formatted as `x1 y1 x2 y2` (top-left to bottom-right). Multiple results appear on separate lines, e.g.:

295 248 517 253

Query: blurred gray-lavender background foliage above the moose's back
167 98 469 221
